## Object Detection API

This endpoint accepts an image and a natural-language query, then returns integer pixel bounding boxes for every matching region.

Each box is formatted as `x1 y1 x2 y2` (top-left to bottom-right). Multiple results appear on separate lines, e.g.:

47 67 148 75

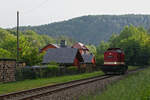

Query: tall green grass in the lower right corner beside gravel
80 68 150 100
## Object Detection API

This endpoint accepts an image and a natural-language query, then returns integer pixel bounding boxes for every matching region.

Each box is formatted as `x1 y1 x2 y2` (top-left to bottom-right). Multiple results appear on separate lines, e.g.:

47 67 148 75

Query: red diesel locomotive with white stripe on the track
101 48 128 74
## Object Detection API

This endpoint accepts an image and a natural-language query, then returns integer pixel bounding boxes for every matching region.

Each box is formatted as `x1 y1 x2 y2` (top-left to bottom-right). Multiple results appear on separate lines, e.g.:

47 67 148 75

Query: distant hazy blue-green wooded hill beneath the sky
17 14 150 44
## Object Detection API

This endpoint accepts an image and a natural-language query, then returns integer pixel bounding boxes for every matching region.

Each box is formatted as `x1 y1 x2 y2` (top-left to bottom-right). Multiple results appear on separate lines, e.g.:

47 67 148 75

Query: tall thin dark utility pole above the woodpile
17 11 19 62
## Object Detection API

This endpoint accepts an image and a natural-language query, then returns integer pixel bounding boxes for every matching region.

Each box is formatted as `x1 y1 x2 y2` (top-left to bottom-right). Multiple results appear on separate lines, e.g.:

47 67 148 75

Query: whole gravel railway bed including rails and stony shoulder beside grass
0 69 145 100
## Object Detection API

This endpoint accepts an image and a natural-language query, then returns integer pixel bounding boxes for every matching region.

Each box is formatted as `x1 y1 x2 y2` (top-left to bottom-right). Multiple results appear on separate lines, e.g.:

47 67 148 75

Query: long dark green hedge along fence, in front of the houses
16 64 95 81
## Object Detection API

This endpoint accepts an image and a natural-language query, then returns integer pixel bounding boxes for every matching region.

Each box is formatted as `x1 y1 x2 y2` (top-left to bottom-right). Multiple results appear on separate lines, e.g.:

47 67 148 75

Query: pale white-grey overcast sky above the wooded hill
0 0 150 28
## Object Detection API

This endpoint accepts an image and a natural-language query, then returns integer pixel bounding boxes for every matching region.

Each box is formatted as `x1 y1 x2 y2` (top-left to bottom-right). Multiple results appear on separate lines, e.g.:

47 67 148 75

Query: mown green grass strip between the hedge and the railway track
0 71 103 94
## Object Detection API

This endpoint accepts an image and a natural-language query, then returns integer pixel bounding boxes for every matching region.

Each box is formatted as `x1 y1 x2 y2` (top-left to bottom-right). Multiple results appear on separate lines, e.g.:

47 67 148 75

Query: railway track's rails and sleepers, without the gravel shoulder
0 69 145 100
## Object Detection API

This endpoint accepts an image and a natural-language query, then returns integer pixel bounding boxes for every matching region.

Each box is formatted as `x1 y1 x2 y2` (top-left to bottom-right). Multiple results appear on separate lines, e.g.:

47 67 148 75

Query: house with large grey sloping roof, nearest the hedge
42 48 84 67
